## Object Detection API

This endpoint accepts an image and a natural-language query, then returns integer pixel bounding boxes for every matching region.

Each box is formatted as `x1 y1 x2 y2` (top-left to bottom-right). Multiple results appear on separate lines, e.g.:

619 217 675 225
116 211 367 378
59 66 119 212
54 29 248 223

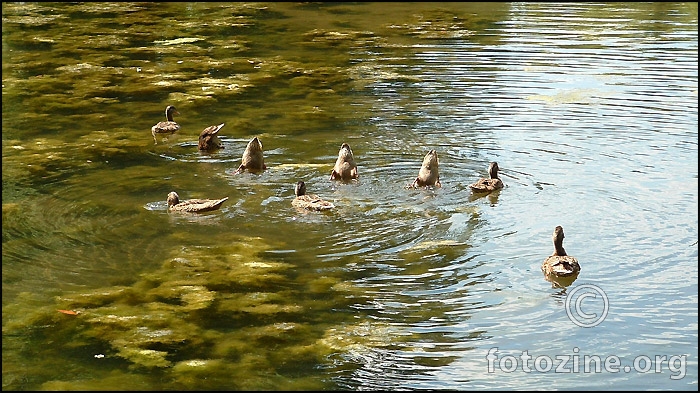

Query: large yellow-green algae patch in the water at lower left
5 237 372 372
